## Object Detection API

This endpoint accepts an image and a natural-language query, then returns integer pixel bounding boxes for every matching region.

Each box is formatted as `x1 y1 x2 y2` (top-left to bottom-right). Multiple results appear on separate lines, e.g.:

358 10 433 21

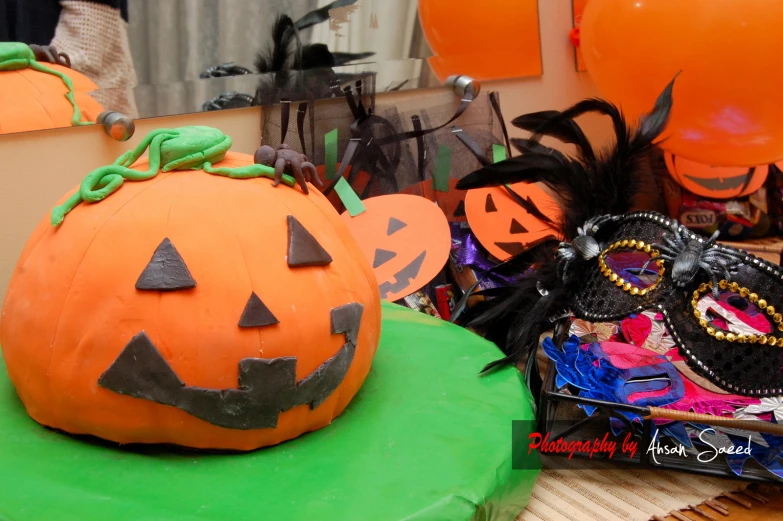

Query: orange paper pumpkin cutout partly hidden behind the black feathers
465 183 560 261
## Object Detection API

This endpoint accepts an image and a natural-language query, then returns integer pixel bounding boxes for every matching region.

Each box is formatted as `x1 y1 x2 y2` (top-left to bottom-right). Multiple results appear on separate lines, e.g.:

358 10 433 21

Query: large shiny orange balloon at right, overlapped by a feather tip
581 0 783 167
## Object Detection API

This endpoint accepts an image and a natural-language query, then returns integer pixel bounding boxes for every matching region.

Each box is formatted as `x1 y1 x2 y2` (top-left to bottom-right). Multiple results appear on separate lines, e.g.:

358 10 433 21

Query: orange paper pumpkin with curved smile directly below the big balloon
664 152 769 199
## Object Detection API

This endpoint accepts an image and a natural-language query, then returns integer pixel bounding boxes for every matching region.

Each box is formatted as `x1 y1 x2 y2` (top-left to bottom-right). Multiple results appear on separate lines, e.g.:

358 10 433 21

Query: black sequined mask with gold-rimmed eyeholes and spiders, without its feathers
558 212 783 397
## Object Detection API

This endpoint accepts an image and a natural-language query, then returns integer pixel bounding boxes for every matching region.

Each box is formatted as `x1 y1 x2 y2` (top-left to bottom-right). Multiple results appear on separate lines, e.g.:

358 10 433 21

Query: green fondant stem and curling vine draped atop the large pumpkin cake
52 127 295 226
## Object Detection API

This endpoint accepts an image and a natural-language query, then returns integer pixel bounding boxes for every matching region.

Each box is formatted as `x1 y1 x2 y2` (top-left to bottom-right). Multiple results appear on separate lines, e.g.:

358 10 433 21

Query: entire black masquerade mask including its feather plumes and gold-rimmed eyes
457 76 783 396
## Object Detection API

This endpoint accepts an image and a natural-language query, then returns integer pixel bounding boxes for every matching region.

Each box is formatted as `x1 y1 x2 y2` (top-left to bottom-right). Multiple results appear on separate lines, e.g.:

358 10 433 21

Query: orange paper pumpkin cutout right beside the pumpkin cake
342 194 451 302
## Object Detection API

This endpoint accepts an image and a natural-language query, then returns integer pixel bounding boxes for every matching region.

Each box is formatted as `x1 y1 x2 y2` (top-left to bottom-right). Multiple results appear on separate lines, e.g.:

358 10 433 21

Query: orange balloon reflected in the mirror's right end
419 0 542 81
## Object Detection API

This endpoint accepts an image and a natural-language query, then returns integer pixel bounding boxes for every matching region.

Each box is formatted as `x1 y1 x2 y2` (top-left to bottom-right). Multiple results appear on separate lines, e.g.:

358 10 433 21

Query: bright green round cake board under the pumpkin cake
0 304 538 521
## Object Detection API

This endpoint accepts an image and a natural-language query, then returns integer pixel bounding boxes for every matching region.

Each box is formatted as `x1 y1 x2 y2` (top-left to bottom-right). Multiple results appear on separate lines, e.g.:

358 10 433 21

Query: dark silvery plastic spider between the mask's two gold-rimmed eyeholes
651 221 745 299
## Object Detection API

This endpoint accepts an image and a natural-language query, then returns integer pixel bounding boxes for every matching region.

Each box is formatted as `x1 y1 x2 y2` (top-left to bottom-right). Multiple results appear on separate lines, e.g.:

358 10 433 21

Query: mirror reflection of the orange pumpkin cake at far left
0 64 103 134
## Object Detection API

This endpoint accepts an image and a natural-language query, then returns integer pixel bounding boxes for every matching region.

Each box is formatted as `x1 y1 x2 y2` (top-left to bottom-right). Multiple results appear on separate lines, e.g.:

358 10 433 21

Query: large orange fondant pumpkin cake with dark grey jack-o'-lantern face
0 153 380 450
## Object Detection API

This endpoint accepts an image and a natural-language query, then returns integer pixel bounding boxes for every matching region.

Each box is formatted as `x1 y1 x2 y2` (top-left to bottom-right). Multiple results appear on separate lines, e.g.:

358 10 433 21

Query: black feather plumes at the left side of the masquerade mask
457 76 673 370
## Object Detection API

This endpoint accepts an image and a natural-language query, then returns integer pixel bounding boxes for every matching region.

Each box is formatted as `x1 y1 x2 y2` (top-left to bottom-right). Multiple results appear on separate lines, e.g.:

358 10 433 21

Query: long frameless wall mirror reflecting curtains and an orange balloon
0 0 541 134
